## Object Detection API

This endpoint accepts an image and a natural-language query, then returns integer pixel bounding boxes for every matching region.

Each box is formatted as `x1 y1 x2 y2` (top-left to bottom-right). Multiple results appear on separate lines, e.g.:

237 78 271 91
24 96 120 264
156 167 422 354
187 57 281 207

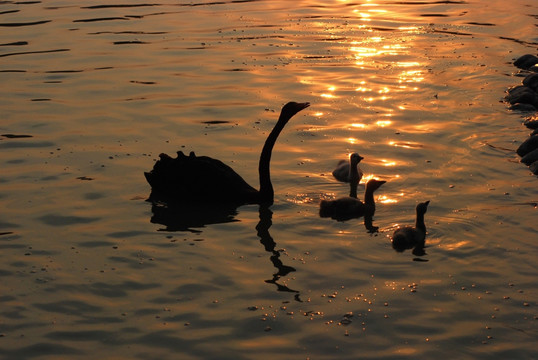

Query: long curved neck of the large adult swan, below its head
258 113 291 204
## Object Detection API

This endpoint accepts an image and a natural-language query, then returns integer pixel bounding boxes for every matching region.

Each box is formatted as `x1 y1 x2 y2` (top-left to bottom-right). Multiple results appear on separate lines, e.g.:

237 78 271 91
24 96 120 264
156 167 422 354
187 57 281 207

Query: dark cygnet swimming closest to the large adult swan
319 179 386 232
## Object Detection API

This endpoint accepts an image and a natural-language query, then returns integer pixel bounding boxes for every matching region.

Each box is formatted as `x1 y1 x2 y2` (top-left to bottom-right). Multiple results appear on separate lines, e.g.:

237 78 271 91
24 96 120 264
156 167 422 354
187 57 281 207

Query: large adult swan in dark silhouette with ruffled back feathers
144 102 310 205
